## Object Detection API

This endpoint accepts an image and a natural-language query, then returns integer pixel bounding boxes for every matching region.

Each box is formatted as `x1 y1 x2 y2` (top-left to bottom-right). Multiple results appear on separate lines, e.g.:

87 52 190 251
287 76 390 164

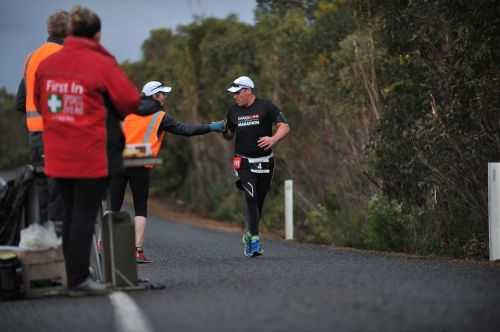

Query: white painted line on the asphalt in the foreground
109 292 153 332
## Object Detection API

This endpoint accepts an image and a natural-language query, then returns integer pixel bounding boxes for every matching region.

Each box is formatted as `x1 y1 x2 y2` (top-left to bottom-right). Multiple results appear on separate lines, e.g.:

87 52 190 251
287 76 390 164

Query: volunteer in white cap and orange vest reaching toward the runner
111 81 224 264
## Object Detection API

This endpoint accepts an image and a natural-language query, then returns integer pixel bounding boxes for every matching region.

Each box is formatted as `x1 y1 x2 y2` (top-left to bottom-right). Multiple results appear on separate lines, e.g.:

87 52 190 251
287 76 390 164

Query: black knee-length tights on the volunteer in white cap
111 167 151 217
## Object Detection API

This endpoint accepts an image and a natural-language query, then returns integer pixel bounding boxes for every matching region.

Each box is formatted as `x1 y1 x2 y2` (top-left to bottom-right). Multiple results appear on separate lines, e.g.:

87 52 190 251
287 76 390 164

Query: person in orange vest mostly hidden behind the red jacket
16 11 69 230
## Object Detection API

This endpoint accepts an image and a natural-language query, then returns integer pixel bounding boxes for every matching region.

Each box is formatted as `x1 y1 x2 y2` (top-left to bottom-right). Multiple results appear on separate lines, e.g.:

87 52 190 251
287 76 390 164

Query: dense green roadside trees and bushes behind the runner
0 0 500 257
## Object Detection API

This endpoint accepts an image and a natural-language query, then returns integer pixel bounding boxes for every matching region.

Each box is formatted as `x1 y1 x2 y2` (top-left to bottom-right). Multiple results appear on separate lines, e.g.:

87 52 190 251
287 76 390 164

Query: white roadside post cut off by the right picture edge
488 163 500 261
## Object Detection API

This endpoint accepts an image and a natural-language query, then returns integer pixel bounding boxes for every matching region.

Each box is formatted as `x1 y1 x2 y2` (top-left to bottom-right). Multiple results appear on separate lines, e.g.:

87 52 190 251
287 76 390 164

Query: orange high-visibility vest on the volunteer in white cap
122 111 166 157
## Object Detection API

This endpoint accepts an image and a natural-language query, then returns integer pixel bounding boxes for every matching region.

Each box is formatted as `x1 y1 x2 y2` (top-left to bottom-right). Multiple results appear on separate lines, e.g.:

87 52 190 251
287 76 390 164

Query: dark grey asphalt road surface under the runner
0 213 500 332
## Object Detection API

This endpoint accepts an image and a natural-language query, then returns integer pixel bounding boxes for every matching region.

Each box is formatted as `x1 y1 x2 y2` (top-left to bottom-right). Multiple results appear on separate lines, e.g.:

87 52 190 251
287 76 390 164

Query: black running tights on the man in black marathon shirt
236 158 274 235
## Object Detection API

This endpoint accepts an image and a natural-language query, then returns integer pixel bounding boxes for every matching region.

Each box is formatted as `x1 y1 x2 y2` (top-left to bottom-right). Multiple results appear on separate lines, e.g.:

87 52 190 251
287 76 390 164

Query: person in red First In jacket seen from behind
35 6 140 295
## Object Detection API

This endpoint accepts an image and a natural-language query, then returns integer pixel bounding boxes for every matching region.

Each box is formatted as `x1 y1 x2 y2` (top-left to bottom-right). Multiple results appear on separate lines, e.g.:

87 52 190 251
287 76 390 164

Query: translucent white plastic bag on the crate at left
19 221 62 250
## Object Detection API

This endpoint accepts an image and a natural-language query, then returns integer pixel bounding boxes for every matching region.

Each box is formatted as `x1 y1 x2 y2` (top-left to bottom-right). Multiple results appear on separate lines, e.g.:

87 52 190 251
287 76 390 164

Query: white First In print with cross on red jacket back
45 80 84 122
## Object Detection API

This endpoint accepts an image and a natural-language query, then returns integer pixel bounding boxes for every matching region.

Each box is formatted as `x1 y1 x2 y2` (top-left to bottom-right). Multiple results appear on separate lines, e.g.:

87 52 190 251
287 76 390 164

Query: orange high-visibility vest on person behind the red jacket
24 42 62 132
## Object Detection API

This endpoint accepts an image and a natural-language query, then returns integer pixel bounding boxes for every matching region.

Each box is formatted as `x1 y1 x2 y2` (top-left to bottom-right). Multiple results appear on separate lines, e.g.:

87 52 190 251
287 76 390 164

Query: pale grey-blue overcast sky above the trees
0 0 256 93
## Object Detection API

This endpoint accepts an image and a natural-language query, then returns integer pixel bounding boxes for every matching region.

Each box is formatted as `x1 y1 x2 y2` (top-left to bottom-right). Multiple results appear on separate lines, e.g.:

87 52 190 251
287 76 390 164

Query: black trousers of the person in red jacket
57 178 108 288
